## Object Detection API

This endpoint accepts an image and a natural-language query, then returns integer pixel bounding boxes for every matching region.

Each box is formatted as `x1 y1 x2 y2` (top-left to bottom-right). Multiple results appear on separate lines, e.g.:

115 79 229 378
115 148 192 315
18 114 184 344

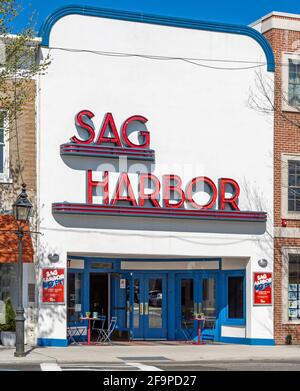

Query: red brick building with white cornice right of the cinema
252 12 300 344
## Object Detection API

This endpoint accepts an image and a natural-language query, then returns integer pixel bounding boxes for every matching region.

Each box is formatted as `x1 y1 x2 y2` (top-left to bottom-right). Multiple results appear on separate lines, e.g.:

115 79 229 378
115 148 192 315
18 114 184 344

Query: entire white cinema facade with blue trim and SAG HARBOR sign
36 6 274 346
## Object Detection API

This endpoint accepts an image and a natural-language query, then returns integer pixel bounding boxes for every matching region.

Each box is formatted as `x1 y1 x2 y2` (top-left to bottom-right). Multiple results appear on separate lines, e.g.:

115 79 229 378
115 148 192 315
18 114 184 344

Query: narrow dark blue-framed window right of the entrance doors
227 276 245 320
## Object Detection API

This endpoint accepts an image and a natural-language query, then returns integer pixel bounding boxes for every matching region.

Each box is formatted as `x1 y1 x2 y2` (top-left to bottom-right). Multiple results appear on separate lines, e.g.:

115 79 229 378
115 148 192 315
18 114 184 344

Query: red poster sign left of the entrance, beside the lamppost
42 268 65 303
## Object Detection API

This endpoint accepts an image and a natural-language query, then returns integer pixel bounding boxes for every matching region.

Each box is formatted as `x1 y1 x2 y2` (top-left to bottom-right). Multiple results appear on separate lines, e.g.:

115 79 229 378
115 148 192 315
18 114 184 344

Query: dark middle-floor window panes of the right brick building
288 161 300 212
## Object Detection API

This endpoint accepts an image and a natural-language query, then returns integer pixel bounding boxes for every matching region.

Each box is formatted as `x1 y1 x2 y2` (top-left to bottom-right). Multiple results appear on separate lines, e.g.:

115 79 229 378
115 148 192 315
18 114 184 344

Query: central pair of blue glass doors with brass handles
133 274 167 339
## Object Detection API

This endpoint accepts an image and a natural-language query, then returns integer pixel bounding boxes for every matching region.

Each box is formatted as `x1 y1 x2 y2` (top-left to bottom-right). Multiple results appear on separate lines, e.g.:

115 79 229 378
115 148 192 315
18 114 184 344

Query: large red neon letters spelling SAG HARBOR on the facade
76 110 240 213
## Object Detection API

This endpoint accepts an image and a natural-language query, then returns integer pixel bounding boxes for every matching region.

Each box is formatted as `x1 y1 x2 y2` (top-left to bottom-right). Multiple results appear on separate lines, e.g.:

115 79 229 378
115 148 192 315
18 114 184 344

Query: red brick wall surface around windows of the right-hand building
264 22 300 344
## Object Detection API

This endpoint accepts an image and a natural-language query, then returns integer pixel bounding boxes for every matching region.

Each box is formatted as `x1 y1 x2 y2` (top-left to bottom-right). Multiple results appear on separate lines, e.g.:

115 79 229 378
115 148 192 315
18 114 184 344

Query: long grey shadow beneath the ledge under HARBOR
53 214 266 235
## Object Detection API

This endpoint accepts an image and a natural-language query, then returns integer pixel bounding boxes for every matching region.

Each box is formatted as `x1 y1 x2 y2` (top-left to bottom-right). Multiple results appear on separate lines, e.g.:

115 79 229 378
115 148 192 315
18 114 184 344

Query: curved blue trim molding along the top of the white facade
39 5 275 72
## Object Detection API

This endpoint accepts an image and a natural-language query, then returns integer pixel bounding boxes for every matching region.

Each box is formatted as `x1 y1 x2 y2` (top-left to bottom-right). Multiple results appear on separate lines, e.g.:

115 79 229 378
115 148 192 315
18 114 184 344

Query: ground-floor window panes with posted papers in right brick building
288 254 300 321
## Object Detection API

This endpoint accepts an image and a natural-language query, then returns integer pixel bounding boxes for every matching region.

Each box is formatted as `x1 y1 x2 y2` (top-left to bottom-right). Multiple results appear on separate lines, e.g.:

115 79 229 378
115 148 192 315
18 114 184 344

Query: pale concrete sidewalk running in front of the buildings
0 342 300 364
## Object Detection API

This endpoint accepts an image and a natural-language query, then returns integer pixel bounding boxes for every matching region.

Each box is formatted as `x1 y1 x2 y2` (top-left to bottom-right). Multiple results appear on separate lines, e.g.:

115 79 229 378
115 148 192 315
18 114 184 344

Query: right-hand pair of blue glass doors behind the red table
175 272 217 339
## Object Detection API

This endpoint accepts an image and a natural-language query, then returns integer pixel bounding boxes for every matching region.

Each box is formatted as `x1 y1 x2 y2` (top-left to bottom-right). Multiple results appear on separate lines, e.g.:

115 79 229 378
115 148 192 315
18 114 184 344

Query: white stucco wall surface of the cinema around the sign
38 11 273 339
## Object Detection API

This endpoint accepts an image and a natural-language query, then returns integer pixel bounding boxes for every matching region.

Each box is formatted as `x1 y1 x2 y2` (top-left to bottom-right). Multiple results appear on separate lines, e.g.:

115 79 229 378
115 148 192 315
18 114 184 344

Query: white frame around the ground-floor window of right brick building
281 247 300 324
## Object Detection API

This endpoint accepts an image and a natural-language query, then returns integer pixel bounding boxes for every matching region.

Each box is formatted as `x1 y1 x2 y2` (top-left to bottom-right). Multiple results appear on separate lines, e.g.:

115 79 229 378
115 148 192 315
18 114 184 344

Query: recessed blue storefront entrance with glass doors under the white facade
68 259 246 341
